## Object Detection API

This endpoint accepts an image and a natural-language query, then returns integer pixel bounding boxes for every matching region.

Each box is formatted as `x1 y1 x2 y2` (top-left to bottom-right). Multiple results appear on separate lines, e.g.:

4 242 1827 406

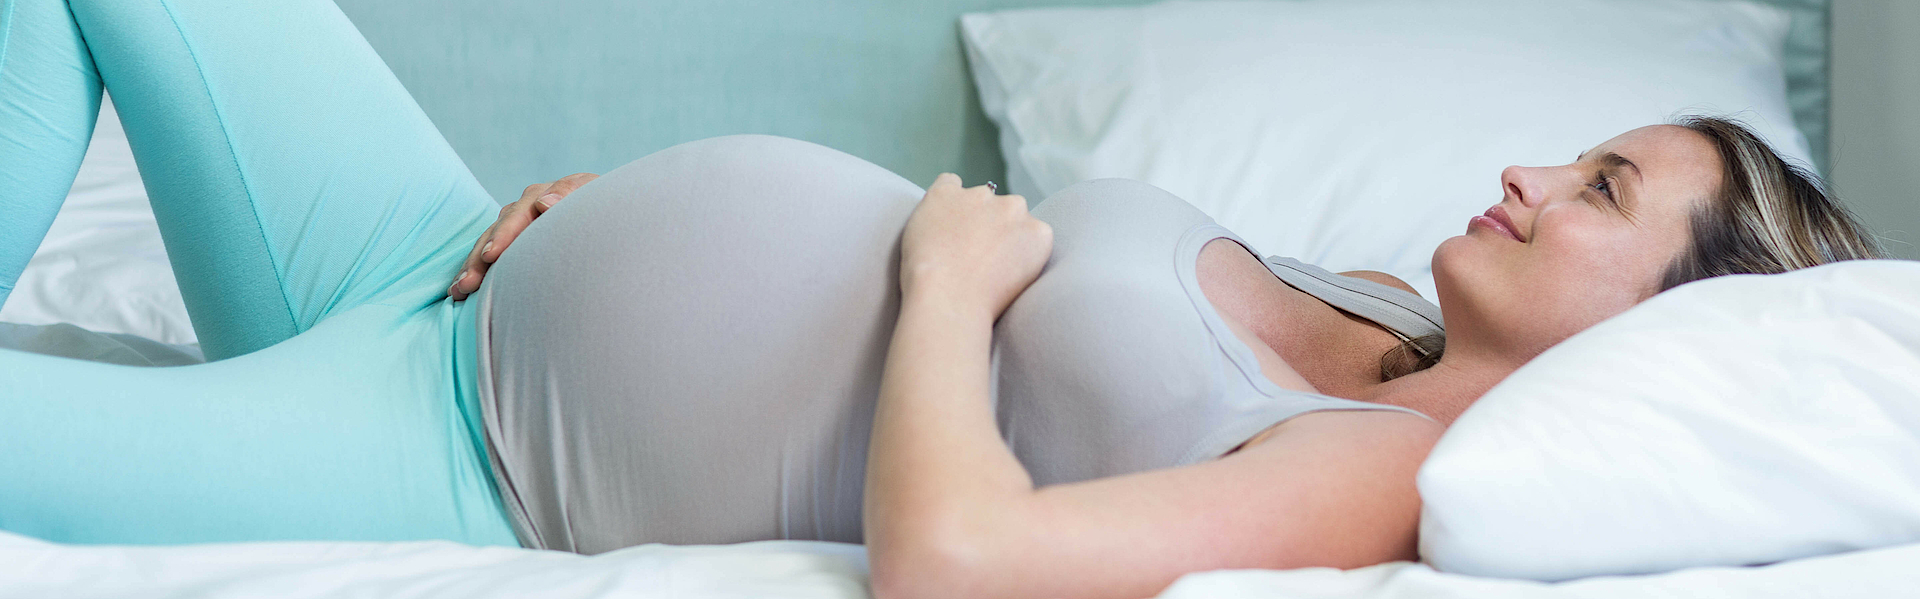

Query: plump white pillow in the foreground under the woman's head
1419 261 1920 584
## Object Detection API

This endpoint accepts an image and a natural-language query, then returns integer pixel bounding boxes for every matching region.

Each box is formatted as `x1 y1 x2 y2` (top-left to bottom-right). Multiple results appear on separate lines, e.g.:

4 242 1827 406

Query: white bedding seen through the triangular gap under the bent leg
0 95 196 344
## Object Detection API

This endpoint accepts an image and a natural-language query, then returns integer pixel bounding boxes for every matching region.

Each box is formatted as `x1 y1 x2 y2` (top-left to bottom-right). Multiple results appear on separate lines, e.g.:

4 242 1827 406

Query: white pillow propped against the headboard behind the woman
960 0 1809 298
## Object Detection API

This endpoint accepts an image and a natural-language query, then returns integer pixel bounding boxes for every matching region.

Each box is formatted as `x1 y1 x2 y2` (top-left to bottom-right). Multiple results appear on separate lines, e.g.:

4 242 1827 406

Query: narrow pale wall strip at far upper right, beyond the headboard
1830 0 1920 259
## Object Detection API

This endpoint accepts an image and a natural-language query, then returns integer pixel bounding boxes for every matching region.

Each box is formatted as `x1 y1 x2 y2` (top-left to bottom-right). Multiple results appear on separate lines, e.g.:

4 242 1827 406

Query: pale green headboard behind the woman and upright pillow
336 0 1828 202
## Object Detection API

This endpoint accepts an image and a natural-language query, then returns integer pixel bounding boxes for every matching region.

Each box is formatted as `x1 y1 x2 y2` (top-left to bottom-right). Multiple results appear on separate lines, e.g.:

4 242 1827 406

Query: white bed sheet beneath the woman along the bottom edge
0 532 1920 599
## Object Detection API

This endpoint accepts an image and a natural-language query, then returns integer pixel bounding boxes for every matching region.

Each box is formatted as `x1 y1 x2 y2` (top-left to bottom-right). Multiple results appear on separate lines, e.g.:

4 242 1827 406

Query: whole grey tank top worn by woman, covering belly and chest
474 136 1440 553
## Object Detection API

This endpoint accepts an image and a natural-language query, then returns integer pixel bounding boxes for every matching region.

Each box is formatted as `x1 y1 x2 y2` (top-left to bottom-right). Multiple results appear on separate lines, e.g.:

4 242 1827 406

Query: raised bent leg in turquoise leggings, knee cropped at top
0 0 497 359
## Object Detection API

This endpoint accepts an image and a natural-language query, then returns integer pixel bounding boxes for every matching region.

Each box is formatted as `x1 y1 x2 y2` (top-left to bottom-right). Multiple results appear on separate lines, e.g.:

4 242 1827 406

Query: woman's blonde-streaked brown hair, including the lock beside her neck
1380 115 1885 380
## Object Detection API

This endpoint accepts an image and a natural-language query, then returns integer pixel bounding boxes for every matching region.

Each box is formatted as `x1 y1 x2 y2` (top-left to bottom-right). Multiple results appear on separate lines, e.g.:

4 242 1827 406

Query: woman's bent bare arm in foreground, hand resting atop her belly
864 175 1440 599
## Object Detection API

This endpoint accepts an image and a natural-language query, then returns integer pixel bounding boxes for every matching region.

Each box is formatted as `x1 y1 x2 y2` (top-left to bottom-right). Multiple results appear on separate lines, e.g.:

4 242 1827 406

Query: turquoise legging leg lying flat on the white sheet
0 303 516 545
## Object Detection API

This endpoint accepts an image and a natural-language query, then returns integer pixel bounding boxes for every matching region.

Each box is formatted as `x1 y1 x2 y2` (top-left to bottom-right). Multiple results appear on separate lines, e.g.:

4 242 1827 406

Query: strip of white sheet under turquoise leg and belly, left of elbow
0 532 868 599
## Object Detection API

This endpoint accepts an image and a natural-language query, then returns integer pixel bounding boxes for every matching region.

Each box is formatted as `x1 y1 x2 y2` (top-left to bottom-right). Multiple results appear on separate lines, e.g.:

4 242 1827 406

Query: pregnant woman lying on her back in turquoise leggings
0 0 1874 597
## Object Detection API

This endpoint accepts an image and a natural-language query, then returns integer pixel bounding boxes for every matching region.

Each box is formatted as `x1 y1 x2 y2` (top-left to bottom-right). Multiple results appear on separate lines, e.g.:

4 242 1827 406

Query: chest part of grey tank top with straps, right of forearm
993 180 1444 484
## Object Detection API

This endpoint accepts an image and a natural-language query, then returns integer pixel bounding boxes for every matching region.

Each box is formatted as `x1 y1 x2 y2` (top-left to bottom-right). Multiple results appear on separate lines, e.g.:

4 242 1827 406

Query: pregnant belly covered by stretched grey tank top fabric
480 136 922 553
